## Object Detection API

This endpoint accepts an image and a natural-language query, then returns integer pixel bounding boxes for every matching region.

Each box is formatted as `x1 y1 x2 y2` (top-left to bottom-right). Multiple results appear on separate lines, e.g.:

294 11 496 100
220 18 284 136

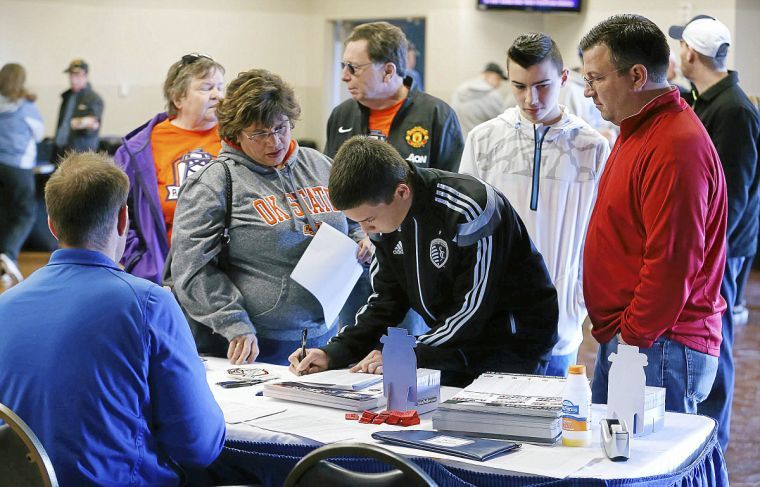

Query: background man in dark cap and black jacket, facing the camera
55 59 103 155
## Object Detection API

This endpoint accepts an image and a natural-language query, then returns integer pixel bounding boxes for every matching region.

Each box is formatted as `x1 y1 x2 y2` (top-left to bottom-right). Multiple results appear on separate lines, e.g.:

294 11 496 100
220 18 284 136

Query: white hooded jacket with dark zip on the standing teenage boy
459 106 610 355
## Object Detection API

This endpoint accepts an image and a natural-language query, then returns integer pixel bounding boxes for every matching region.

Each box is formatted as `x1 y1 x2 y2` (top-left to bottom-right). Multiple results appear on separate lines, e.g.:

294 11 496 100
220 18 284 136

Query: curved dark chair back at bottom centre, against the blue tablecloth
285 443 437 487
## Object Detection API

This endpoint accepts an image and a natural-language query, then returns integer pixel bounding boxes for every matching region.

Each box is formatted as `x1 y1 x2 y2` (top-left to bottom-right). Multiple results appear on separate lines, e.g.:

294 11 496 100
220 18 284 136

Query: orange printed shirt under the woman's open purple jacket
150 119 222 242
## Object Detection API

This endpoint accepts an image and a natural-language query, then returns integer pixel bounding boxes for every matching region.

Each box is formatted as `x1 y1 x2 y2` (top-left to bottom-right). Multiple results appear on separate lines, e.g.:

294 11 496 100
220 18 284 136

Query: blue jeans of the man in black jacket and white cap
697 257 745 452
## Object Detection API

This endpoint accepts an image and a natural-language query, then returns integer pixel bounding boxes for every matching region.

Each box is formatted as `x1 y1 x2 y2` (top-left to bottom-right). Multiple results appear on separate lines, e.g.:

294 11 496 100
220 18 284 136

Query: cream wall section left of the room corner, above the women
0 0 317 142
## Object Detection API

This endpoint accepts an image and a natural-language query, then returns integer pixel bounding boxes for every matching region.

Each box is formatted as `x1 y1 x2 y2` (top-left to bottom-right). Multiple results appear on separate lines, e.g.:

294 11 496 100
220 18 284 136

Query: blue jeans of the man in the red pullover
591 336 718 414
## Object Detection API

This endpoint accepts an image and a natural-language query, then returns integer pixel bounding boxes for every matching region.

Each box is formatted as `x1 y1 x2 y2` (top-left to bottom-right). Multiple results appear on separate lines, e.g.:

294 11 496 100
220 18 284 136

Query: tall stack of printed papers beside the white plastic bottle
433 372 565 444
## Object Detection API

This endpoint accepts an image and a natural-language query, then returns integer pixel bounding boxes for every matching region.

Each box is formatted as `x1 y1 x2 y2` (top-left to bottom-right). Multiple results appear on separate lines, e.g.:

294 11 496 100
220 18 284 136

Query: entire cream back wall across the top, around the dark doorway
0 0 760 151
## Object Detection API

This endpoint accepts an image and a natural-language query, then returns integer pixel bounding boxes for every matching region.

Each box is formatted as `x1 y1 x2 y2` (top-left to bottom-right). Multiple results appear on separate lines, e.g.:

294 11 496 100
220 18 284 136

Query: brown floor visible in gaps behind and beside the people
4 252 760 486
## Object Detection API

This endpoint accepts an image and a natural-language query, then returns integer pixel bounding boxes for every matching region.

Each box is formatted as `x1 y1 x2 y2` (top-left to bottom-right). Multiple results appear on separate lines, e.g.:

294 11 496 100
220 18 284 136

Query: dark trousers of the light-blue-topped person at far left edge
0 163 37 262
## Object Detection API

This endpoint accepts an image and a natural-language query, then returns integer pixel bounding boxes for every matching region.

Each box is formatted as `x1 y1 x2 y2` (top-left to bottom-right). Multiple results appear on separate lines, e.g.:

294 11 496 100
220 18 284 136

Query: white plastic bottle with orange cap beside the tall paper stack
562 365 591 446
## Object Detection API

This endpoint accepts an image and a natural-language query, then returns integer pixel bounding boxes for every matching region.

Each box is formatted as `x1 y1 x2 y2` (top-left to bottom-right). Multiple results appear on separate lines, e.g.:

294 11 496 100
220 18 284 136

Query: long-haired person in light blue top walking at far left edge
0 63 45 288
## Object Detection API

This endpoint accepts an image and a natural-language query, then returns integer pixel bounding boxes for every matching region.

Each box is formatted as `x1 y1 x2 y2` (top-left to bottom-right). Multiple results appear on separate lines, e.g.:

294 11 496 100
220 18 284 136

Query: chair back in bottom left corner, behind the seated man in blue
0 404 58 487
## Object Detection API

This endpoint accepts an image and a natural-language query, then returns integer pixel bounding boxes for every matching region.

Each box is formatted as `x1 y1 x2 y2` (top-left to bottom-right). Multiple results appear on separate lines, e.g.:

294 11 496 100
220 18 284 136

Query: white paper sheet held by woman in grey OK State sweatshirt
290 222 362 326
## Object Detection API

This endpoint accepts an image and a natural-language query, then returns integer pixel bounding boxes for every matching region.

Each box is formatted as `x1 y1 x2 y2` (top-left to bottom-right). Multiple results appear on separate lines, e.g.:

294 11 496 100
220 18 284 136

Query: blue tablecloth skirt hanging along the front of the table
190 429 729 487
